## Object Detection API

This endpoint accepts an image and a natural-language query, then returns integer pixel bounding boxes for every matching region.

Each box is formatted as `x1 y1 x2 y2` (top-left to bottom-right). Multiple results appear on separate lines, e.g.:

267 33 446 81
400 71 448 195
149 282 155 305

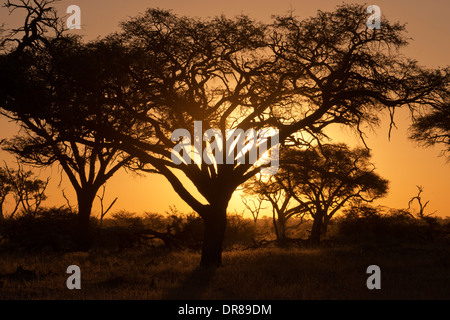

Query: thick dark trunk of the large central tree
200 205 227 268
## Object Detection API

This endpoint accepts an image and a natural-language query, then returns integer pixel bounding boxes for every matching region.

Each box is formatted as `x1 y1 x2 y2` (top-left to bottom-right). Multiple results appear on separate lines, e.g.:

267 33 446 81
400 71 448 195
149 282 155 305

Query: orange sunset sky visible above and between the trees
0 0 450 216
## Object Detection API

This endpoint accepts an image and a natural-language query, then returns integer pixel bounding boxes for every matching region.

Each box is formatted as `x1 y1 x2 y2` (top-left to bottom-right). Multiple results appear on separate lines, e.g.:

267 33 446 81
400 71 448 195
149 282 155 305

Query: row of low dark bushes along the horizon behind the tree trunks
0 205 450 252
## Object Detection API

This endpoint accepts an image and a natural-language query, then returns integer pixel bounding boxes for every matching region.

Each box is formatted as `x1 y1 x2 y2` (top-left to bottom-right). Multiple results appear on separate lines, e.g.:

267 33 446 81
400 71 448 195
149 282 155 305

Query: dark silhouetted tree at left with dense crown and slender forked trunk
0 1 131 249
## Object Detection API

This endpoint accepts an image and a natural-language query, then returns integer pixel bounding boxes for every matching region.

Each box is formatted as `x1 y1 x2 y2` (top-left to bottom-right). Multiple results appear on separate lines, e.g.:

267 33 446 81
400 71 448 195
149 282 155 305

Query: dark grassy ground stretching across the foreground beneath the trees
0 245 450 300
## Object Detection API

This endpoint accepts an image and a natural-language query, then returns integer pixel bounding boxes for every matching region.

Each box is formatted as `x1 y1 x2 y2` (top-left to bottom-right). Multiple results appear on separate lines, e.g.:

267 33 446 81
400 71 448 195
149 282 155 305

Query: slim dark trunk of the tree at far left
75 192 95 251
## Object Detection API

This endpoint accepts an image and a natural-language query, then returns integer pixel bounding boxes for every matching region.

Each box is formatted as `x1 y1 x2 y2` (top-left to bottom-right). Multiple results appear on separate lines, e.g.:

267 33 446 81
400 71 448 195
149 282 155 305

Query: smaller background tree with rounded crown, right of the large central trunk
246 144 388 243
